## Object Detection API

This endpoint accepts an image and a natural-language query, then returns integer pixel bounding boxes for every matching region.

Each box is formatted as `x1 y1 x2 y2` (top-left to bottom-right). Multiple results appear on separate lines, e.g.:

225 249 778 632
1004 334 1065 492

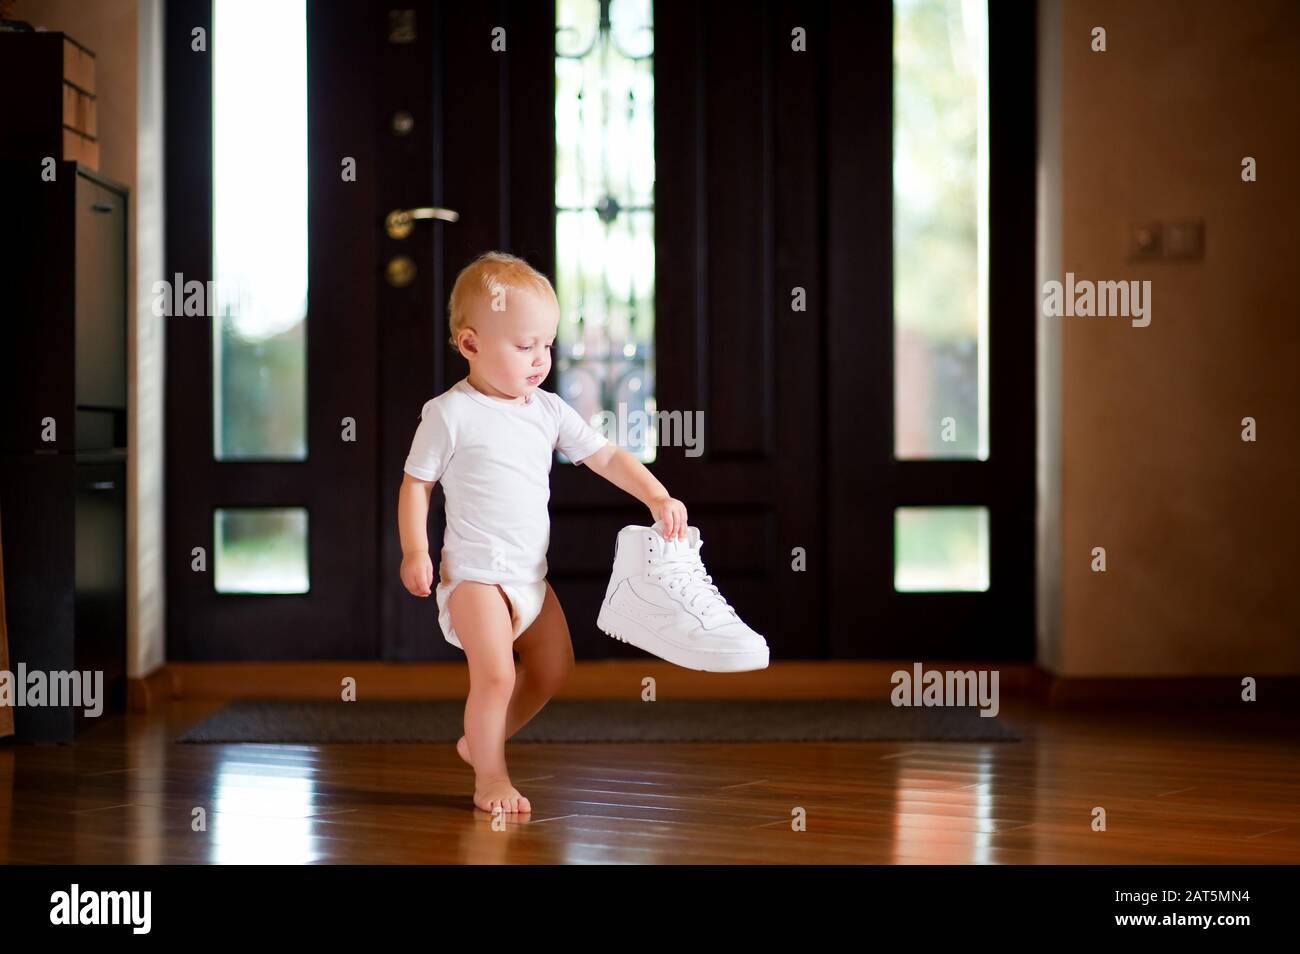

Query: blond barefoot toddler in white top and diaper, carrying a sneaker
398 252 688 812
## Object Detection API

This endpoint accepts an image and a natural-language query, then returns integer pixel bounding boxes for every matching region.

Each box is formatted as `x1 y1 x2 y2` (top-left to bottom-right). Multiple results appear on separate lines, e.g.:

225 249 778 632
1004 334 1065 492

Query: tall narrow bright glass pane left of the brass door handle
208 0 307 460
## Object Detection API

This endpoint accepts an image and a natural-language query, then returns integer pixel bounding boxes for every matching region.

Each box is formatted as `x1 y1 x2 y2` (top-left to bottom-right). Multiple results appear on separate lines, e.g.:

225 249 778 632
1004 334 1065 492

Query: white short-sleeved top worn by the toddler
404 378 608 584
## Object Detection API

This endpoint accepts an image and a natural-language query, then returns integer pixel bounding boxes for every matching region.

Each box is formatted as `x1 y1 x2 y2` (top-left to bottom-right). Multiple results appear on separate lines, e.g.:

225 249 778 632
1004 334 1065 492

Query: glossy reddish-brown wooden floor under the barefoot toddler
0 701 1300 864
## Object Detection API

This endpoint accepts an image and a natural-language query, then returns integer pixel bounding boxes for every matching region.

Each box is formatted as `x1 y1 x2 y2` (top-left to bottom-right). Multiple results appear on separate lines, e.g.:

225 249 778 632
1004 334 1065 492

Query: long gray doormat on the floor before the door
177 699 1021 743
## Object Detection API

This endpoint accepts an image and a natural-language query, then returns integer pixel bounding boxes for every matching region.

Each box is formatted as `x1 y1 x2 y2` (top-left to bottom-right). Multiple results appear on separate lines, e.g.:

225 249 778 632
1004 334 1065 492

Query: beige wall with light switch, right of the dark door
1039 0 1300 676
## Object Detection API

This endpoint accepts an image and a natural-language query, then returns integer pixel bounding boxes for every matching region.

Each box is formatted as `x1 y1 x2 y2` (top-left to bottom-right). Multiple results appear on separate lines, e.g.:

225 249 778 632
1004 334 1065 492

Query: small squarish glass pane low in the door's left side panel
213 507 311 593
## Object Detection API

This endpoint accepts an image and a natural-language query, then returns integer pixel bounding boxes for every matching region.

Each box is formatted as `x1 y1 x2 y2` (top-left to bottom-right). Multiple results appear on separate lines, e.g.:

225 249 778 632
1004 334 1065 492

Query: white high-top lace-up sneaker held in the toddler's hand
595 521 767 672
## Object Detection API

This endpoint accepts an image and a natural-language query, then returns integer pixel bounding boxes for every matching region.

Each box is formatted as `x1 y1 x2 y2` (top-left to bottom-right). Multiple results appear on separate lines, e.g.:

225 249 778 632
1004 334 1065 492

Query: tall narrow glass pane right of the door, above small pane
893 0 988 460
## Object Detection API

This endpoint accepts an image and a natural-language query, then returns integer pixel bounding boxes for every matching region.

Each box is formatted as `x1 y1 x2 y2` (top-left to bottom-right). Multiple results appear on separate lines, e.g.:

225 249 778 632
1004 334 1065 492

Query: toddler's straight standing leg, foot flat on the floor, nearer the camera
447 581 532 811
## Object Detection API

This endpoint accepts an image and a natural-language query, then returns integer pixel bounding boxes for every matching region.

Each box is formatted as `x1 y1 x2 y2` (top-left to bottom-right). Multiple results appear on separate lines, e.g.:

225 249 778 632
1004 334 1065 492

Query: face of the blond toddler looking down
460 289 560 399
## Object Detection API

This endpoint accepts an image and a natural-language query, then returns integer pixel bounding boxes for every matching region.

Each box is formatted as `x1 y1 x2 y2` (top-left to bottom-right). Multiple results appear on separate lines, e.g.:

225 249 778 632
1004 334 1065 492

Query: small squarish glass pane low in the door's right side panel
894 507 988 593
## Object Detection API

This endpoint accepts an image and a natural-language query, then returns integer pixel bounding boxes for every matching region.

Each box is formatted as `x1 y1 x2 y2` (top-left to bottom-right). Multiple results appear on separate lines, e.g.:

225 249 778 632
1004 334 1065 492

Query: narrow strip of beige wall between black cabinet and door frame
16 0 165 677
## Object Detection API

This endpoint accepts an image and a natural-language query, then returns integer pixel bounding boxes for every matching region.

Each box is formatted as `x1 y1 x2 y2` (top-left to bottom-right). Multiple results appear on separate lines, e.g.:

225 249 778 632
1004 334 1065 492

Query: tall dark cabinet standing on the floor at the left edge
0 161 127 742
